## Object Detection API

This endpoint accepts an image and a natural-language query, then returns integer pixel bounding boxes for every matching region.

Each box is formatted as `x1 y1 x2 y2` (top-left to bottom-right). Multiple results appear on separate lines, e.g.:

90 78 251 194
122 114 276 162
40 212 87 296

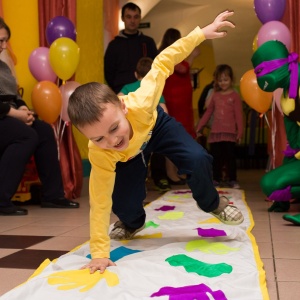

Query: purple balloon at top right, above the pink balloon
254 0 286 24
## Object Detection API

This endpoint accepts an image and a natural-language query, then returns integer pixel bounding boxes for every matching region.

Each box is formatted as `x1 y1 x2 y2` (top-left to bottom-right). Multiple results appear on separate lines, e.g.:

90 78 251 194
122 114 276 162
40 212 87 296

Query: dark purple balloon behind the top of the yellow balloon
46 16 76 46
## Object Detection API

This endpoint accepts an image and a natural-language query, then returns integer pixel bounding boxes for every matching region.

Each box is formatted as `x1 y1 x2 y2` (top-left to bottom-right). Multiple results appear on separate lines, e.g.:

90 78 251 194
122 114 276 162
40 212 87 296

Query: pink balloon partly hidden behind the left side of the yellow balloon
28 47 57 82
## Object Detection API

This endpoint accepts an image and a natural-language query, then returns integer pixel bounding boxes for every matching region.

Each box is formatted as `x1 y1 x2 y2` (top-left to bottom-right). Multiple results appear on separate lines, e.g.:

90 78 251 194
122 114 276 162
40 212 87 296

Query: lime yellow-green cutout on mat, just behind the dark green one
185 240 240 254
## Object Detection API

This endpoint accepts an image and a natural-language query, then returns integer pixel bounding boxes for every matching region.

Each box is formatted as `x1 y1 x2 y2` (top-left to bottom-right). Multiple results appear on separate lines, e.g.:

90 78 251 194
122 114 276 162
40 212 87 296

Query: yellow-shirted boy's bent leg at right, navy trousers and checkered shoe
146 109 243 224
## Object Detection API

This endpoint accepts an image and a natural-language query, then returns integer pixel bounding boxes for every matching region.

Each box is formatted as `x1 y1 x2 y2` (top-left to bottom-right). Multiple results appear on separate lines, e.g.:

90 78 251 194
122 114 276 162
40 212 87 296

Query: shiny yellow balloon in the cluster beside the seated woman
49 37 80 81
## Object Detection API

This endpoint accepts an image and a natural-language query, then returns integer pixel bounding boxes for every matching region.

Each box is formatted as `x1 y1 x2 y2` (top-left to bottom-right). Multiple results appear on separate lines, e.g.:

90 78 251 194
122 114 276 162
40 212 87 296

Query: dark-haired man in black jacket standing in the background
104 2 157 93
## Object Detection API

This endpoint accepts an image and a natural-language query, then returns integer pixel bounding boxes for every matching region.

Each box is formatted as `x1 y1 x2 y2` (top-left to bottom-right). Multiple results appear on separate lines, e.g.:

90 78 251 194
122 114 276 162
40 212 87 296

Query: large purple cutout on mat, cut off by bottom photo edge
151 283 227 300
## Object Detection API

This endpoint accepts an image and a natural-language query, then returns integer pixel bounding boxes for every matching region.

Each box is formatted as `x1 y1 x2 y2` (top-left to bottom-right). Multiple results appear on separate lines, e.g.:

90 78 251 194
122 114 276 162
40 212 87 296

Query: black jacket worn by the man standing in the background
104 31 157 93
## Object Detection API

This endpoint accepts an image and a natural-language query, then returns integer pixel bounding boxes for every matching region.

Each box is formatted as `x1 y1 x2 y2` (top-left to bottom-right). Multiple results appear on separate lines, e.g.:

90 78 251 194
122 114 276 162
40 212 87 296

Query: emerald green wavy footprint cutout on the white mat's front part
166 254 232 278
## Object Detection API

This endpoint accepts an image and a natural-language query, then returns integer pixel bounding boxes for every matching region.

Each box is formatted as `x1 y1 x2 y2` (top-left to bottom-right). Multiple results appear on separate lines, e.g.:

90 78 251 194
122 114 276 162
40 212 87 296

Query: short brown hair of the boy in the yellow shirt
68 82 121 127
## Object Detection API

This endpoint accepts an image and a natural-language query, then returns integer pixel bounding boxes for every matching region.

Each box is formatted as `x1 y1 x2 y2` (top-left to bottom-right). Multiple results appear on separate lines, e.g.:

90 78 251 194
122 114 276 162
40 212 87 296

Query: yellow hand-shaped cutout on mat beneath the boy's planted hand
48 269 119 292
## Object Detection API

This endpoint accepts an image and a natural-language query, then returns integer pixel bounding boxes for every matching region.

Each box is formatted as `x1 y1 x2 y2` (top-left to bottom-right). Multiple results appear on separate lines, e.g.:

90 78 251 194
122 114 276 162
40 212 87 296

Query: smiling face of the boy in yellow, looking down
78 101 132 151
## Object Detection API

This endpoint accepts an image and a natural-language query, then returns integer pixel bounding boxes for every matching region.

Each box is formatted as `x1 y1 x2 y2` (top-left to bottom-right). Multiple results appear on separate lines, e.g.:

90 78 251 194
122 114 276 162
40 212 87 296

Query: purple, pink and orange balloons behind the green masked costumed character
240 0 291 114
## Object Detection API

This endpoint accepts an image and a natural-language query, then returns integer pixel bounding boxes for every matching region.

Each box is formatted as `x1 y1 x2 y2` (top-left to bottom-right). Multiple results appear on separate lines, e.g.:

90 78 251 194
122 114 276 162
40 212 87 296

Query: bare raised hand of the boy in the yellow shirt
202 10 235 39
